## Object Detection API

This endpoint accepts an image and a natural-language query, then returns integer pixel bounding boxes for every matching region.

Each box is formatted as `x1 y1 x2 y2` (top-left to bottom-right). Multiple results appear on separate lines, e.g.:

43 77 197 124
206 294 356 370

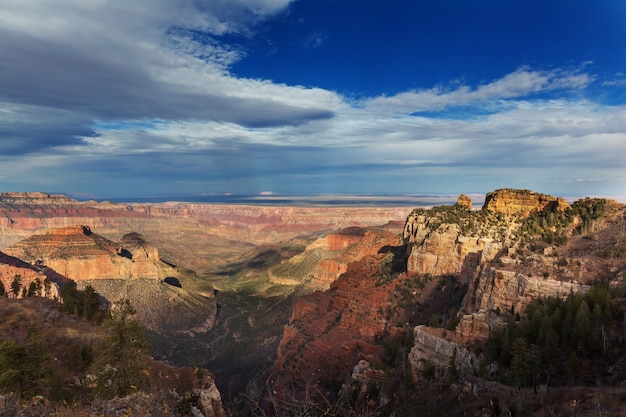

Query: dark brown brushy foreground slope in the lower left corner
0 297 225 417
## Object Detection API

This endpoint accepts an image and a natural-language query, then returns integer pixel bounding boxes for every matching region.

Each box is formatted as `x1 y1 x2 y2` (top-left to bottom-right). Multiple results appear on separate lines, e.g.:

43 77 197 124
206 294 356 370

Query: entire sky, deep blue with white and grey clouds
0 0 626 201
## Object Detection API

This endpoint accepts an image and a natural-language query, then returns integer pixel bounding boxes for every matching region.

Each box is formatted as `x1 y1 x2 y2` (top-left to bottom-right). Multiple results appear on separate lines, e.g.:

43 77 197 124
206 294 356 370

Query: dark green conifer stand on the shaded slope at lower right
484 285 626 387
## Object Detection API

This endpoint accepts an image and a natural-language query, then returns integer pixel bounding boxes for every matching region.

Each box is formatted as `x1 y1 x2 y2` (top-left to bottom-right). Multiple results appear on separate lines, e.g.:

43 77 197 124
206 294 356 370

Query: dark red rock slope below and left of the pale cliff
274 255 390 387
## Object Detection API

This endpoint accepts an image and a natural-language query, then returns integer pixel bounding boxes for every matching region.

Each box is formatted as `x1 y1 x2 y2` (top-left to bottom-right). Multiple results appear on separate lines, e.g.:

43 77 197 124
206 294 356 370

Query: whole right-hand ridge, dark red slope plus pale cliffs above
274 189 626 412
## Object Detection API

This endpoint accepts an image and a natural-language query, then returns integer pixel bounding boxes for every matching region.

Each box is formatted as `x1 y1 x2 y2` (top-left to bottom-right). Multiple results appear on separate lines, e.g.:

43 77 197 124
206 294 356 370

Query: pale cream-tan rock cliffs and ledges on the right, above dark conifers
405 190 626 380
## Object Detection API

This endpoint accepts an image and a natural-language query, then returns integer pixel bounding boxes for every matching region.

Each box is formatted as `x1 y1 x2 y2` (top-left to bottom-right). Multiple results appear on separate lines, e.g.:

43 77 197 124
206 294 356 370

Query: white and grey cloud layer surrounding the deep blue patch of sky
0 0 626 196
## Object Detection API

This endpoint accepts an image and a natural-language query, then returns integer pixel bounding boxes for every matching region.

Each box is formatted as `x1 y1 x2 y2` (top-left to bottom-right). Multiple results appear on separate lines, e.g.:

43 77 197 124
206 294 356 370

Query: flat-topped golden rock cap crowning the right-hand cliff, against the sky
483 188 569 216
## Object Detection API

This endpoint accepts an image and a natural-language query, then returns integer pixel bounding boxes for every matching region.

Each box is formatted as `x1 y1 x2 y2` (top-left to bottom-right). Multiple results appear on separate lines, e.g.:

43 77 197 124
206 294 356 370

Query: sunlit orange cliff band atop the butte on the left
5 226 160 281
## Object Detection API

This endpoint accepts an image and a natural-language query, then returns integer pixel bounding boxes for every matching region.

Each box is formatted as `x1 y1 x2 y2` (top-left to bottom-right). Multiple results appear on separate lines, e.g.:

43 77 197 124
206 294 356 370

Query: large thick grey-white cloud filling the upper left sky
0 0 332 126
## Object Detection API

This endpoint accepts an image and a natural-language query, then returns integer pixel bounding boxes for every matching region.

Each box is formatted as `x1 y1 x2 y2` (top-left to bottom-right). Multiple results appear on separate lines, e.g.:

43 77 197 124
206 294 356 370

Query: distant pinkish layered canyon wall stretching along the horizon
0 193 411 273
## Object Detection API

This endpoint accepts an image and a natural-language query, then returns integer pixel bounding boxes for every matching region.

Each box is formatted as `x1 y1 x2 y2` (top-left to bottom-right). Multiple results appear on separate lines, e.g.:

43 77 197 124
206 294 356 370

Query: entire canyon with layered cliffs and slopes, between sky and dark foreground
0 189 626 415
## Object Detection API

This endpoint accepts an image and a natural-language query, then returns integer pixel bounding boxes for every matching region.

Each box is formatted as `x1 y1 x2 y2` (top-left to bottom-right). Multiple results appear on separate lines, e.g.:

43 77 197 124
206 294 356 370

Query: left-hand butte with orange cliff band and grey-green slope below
3 226 217 333
